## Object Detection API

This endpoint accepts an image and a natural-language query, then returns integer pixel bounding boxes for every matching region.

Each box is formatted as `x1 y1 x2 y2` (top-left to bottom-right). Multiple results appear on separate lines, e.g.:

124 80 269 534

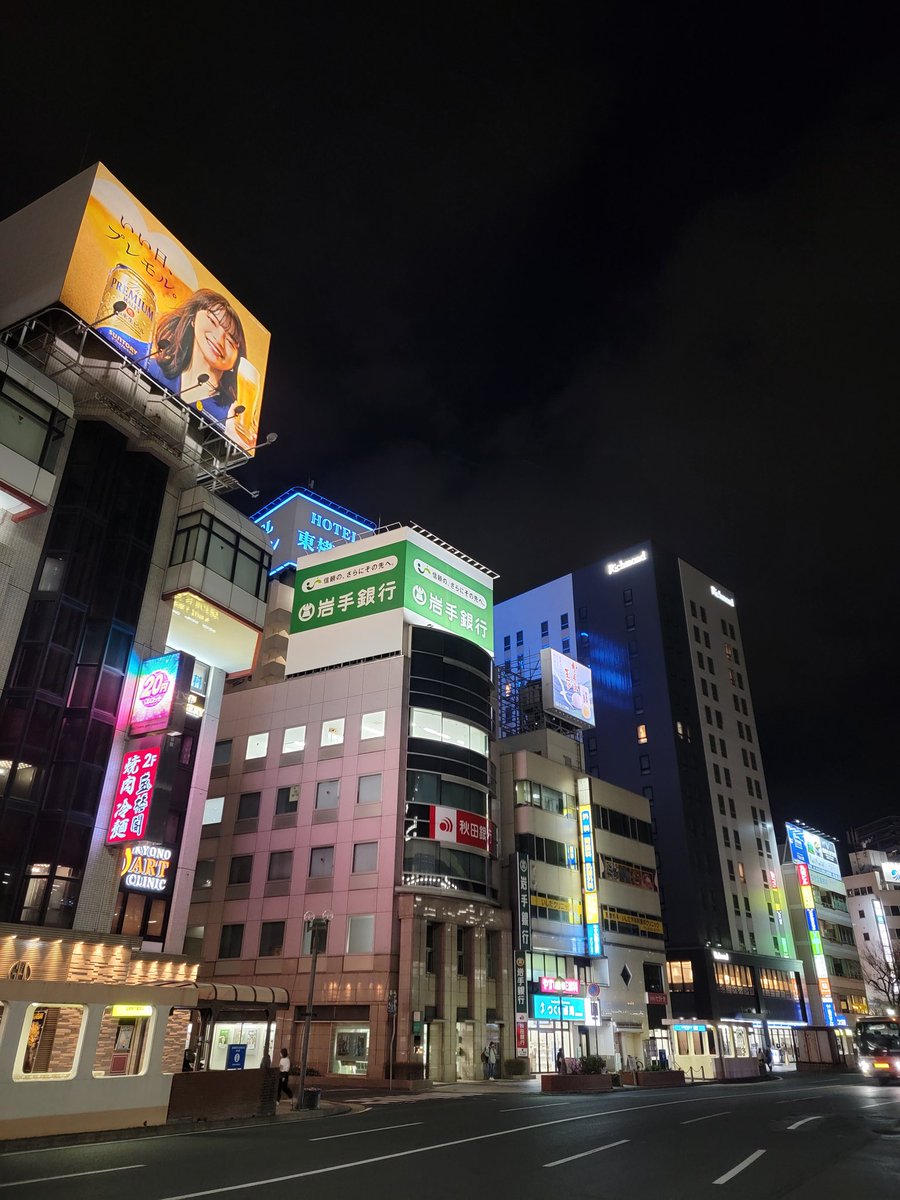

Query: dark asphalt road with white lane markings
0 1076 900 1200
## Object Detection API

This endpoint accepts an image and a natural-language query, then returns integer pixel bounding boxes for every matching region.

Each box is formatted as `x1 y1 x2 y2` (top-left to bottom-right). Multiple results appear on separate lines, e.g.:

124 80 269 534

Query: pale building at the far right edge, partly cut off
844 850 900 1015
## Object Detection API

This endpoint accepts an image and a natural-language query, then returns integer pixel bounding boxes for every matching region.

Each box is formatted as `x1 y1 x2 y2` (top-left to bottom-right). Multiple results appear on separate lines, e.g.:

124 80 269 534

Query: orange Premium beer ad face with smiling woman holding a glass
53 163 269 452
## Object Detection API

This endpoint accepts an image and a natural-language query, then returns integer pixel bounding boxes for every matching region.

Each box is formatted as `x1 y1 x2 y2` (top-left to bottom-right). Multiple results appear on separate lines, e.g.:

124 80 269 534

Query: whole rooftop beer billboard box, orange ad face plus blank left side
0 163 269 452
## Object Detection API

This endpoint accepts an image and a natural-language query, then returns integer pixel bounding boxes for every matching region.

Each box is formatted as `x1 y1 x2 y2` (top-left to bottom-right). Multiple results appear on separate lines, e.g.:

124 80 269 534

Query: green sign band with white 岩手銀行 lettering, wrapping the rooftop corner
290 541 493 653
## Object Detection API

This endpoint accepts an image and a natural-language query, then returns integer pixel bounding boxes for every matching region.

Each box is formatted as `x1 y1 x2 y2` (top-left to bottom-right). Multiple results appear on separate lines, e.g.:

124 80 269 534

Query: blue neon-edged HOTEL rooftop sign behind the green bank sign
251 487 376 575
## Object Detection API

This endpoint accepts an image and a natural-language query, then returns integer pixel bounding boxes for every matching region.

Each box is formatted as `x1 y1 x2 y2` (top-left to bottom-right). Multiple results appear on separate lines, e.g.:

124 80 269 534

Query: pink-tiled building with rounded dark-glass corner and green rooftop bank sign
190 527 515 1080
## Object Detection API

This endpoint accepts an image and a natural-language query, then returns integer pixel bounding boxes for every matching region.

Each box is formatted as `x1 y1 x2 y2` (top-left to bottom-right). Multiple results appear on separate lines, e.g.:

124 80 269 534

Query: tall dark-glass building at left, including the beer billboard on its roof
0 166 282 1128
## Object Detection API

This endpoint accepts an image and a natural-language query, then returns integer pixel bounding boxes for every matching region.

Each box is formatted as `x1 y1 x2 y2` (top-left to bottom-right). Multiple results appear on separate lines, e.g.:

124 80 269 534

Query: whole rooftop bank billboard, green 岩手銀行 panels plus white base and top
286 529 493 673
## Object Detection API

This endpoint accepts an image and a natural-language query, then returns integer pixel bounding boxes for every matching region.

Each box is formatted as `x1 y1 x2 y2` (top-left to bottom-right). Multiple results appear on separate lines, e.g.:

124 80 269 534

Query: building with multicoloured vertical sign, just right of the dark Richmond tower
781 822 869 1028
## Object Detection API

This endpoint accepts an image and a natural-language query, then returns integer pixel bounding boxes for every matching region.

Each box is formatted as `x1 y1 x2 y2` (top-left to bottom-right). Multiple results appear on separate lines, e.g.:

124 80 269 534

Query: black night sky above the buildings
0 0 900 835
